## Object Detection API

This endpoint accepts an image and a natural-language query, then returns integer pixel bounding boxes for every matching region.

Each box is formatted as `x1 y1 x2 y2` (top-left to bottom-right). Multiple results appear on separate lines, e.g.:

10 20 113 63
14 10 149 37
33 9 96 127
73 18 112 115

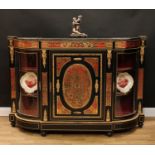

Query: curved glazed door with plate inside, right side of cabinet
113 49 139 119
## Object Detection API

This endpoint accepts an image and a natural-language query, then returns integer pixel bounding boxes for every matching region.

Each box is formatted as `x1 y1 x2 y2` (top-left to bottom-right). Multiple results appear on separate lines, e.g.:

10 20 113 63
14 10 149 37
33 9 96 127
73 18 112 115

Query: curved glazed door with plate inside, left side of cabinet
15 50 40 119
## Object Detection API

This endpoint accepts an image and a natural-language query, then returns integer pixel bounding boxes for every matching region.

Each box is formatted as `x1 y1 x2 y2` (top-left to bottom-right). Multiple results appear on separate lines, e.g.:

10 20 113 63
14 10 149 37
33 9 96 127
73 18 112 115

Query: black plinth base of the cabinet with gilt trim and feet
10 114 144 137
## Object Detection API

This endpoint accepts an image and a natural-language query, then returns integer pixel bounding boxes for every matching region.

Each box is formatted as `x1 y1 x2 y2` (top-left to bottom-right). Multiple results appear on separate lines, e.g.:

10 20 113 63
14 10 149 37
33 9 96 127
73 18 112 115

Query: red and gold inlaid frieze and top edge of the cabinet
8 36 146 49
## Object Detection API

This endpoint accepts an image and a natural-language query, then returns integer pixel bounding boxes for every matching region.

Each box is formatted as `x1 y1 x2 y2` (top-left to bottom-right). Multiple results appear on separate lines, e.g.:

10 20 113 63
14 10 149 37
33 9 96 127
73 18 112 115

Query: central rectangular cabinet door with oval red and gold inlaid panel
49 51 105 120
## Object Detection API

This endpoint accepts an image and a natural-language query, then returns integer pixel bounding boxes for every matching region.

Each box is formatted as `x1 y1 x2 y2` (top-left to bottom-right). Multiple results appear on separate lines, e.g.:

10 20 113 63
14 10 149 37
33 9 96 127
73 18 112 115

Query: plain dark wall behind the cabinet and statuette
0 10 155 107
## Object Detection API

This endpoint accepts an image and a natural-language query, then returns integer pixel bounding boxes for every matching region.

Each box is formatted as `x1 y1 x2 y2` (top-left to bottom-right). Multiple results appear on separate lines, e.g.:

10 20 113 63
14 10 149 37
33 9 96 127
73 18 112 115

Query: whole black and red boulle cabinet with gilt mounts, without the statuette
8 36 146 136
